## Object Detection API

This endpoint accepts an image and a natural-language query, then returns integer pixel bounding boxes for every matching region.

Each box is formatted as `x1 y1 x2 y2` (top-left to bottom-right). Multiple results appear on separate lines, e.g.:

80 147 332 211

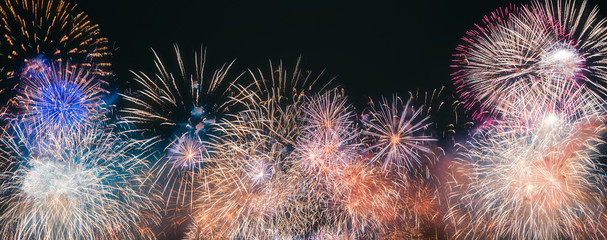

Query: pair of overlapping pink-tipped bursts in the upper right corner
453 1 607 119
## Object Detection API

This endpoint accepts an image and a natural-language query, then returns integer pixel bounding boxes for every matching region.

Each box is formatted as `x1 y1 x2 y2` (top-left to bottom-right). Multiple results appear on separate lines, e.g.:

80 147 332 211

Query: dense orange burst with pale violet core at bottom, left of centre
184 138 298 239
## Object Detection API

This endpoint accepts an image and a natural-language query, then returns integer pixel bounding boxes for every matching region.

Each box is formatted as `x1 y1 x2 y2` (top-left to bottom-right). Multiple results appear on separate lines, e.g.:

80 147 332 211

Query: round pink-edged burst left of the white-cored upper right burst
453 3 556 118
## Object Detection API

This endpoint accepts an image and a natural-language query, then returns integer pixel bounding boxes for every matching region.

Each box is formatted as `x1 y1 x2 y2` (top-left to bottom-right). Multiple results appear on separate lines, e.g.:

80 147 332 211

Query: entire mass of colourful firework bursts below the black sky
0 0 607 239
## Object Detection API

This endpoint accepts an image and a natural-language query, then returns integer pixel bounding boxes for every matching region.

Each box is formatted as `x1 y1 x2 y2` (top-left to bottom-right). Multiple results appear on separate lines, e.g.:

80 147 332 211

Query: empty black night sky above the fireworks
76 0 607 101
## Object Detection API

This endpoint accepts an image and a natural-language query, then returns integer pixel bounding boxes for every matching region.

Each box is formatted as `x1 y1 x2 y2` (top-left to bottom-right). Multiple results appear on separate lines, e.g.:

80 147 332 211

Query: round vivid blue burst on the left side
13 60 105 134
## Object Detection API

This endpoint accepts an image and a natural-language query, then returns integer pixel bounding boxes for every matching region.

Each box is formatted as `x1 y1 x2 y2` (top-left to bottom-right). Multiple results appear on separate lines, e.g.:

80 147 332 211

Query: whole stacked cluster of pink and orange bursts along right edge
445 1 607 239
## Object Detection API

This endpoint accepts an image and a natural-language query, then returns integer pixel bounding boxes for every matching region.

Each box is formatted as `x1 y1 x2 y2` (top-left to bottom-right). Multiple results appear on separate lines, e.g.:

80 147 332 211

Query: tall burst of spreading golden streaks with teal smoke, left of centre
122 45 238 213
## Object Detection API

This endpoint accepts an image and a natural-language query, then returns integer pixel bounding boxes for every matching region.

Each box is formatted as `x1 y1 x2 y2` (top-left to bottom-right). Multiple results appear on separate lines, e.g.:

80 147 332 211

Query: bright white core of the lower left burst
21 160 96 200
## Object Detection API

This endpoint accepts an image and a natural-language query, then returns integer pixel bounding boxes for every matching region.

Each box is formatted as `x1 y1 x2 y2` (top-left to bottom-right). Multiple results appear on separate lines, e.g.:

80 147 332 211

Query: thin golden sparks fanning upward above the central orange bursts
231 59 330 150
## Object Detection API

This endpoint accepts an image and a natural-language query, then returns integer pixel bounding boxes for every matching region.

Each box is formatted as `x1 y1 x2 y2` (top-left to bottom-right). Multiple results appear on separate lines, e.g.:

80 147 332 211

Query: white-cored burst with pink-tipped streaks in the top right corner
527 0 607 91
